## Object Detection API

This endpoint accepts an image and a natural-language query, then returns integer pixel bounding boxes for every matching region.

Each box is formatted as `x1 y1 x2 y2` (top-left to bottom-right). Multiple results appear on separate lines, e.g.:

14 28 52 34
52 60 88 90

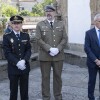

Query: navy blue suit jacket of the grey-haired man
84 28 100 67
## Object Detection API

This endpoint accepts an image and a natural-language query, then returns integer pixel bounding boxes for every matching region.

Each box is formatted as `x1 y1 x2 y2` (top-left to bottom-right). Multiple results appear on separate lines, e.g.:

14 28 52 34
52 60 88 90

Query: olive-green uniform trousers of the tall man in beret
40 61 63 100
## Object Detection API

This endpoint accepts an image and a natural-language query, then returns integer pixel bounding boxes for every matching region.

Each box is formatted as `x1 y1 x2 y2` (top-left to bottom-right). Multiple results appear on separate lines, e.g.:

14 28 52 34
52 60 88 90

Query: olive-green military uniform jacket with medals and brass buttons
36 20 67 61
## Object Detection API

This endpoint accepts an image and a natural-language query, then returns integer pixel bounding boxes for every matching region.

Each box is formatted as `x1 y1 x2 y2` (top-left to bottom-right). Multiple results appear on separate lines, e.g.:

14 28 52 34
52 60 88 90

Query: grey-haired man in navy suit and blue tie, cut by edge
84 14 100 100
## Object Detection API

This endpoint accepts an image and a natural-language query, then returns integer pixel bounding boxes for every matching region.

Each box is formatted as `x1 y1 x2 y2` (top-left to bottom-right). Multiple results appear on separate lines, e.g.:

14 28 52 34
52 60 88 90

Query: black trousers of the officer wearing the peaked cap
9 73 29 100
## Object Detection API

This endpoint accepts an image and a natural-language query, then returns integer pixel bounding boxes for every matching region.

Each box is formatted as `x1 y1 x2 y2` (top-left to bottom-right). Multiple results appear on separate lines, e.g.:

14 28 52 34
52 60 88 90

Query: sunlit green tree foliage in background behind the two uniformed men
1 0 53 17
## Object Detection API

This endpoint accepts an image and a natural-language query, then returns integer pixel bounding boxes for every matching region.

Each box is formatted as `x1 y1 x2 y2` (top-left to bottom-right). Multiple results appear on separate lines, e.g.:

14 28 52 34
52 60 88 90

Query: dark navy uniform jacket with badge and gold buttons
3 31 31 74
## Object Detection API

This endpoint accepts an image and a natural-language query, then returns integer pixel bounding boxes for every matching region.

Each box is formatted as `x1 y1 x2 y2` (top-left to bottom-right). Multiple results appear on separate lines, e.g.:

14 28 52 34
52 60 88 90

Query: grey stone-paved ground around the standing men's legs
0 63 99 100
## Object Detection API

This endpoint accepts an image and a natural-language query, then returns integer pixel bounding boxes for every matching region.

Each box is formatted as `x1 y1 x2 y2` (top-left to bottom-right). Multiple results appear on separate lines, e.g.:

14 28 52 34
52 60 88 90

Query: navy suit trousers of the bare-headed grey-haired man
88 66 100 100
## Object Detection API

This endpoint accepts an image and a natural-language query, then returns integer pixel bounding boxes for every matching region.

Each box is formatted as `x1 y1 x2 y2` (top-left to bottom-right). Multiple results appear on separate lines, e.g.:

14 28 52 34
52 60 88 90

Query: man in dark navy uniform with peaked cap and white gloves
3 15 31 100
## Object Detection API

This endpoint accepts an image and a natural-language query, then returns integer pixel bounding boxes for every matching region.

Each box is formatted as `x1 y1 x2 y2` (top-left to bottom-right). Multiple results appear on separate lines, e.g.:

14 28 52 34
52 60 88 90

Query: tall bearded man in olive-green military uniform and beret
36 5 67 100
